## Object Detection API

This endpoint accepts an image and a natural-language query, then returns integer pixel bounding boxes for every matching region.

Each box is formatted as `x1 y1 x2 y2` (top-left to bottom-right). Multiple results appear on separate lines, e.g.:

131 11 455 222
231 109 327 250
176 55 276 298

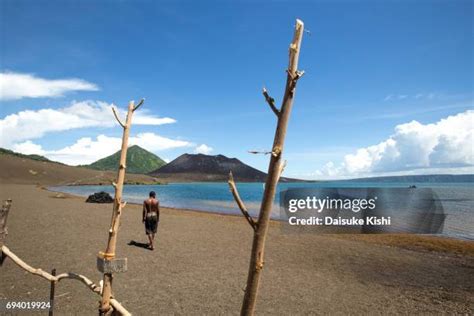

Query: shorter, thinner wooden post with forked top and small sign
99 99 144 314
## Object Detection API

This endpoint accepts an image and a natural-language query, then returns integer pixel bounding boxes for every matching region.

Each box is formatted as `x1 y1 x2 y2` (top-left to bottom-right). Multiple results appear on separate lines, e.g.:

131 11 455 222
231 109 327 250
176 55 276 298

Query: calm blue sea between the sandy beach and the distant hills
49 181 474 241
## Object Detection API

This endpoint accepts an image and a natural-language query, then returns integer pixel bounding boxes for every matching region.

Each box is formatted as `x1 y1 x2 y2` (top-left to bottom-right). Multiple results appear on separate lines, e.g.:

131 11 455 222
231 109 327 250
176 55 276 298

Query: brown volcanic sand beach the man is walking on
0 184 474 315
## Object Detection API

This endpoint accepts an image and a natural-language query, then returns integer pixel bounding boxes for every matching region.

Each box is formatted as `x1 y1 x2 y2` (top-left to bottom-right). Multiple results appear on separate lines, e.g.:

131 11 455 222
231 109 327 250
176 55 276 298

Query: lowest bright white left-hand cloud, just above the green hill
13 133 194 166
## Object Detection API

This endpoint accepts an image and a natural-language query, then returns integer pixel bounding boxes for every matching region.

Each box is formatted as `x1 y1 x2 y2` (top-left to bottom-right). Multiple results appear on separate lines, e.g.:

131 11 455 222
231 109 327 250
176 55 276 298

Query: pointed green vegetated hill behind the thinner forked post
84 145 166 174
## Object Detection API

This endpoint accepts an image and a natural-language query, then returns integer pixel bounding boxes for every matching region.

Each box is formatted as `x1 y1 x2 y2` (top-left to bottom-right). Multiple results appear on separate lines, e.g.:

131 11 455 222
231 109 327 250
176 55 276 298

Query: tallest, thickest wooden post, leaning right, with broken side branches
229 20 304 315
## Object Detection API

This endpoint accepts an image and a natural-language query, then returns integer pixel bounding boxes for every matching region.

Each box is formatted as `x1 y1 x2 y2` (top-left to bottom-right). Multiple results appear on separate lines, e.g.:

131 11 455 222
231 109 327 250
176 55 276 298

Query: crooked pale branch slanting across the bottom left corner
2 245 131 315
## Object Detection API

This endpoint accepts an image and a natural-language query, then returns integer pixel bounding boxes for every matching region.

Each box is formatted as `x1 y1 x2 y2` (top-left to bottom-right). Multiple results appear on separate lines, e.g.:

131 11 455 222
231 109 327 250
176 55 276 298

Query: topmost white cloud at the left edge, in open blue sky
0 72 99 100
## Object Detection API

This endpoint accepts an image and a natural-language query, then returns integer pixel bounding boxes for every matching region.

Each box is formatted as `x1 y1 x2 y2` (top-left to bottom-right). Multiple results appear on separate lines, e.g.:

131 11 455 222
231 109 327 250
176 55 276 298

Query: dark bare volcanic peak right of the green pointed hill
150 154 266 181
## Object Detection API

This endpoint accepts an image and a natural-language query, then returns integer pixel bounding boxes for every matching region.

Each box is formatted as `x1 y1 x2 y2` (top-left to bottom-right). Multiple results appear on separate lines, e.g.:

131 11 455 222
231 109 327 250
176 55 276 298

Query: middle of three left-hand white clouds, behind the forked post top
0 100 176 147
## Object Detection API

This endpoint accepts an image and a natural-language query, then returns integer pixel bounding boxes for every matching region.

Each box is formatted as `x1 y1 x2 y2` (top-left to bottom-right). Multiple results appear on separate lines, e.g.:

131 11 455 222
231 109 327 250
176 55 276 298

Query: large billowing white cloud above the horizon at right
315 110 474 178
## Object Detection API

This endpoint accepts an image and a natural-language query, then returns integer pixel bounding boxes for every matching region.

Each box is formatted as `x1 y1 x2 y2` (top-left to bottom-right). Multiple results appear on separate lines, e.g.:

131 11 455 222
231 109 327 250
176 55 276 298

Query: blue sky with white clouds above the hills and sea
0 0 474 179
